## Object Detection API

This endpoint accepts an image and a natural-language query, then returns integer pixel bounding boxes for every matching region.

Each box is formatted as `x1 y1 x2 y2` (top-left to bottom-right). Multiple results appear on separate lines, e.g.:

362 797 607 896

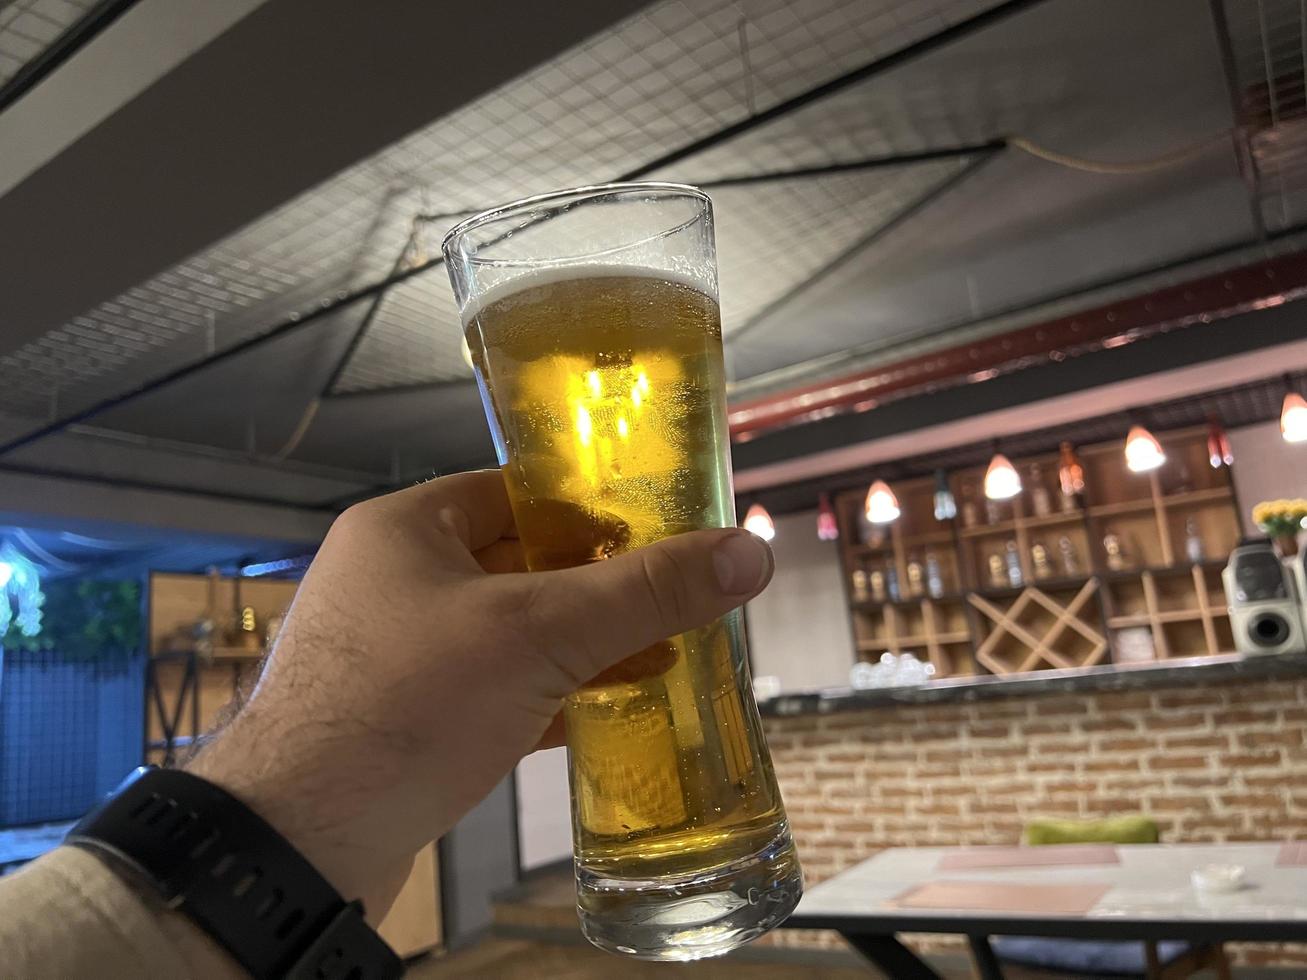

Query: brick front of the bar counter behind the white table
766 679 1307 963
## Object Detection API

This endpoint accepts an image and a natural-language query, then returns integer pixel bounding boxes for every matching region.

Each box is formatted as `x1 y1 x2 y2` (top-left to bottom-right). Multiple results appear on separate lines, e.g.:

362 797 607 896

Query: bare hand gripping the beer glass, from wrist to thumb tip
190 470 772 921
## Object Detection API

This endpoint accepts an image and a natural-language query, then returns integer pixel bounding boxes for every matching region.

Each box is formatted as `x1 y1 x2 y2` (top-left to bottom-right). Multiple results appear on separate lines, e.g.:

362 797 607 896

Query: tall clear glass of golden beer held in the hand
444 183 802 960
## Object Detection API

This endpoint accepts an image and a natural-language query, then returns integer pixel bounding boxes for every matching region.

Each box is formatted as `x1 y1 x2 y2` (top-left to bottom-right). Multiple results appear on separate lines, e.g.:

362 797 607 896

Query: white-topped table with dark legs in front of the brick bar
786 843 1307 980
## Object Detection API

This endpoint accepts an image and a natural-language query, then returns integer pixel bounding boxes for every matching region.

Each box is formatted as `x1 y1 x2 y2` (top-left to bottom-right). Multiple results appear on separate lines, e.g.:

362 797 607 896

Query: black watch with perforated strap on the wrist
64 767 404 980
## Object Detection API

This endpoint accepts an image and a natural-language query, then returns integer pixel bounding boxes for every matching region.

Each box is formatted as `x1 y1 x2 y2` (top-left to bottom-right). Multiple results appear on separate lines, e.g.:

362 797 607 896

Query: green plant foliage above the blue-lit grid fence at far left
0 579 144 662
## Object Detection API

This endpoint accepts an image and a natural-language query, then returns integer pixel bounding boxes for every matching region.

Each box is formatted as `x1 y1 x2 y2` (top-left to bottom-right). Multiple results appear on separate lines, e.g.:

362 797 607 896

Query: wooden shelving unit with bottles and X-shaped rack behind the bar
834 430 1239 677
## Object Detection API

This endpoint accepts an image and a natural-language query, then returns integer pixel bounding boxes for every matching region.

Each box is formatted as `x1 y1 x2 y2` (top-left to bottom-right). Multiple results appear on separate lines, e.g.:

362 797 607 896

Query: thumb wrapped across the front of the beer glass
495 528 774 696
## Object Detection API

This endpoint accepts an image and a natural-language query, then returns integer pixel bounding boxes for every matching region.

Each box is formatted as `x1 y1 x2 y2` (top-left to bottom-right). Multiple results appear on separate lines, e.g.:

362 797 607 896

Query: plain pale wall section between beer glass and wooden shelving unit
748 511 855 693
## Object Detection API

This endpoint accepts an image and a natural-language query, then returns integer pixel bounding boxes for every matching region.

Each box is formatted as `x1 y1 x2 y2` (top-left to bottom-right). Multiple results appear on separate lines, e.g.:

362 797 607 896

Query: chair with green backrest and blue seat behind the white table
989 817 1230 980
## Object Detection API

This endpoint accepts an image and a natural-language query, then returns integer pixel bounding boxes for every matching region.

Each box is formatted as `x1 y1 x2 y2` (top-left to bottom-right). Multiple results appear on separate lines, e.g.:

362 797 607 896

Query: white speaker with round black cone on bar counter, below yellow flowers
1221 541 1307 653
